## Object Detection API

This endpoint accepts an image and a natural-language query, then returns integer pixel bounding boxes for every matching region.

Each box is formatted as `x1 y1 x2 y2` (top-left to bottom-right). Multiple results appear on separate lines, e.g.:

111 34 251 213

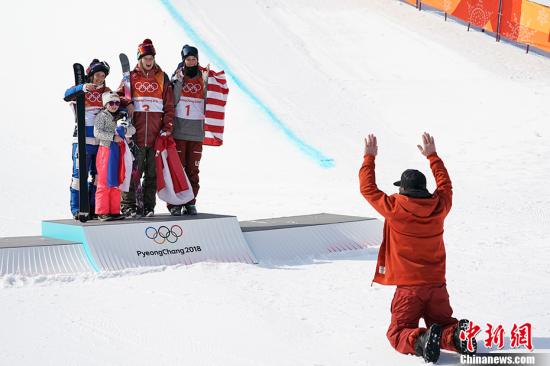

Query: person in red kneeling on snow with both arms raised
359 133 477 362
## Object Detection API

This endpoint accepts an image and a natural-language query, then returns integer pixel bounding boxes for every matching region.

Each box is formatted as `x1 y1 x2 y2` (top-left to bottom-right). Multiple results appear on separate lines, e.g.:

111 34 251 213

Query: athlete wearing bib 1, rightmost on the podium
168 45 208 216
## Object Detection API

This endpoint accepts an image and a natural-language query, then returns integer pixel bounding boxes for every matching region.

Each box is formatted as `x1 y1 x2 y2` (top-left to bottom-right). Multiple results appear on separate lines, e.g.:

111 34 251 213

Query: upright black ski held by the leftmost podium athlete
73 63 90 222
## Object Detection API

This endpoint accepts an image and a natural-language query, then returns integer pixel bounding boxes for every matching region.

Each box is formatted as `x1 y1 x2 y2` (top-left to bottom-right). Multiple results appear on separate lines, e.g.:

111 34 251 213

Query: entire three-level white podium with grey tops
0 213 383 276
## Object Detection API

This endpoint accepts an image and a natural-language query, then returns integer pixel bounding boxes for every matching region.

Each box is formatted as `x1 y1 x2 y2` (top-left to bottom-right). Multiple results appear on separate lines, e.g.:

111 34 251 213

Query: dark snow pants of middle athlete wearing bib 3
122 146 157 210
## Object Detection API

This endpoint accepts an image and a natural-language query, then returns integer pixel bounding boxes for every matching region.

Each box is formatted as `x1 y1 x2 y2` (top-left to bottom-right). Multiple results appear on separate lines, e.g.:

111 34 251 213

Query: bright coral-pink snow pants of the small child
95 146 120 215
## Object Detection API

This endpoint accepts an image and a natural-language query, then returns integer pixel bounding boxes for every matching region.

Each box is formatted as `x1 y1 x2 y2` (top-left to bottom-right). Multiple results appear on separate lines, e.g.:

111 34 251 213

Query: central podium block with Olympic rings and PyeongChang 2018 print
42 214 257 272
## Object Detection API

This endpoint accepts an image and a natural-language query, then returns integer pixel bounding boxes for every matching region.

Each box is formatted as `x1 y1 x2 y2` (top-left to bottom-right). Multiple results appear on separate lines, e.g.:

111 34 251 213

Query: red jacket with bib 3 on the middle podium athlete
117 64 175 147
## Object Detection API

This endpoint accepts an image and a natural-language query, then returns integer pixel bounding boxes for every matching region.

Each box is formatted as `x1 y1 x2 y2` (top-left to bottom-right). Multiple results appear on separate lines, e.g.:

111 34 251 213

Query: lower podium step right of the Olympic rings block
240 213 383 263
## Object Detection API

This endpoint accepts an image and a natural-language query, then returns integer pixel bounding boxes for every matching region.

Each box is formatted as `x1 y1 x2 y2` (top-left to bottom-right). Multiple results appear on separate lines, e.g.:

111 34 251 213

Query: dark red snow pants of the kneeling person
386 284 458 354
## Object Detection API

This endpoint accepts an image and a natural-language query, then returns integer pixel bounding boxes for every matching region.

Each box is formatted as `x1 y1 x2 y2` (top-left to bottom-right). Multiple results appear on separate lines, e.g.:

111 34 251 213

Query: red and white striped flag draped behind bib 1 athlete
203 70 229 146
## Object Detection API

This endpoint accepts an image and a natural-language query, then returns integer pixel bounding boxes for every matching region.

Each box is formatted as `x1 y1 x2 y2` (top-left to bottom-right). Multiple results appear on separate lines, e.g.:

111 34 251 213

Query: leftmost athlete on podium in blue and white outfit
64 59 111 220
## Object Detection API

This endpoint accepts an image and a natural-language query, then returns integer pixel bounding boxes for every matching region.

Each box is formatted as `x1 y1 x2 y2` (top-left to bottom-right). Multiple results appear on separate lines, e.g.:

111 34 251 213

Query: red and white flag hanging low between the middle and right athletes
155 136 195 205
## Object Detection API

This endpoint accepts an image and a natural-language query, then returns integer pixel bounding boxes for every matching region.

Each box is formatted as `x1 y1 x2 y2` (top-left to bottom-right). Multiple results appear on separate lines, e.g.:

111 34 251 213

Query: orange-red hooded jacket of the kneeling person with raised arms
359 154 453 286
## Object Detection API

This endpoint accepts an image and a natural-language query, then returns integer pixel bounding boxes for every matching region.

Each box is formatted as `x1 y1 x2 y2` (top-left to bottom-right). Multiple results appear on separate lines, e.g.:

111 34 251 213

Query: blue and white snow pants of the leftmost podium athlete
70 143 98 216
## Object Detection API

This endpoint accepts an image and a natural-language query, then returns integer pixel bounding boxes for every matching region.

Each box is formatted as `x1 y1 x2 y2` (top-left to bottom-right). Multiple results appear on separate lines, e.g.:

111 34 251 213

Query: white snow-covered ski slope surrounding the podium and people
0 0 550 365
